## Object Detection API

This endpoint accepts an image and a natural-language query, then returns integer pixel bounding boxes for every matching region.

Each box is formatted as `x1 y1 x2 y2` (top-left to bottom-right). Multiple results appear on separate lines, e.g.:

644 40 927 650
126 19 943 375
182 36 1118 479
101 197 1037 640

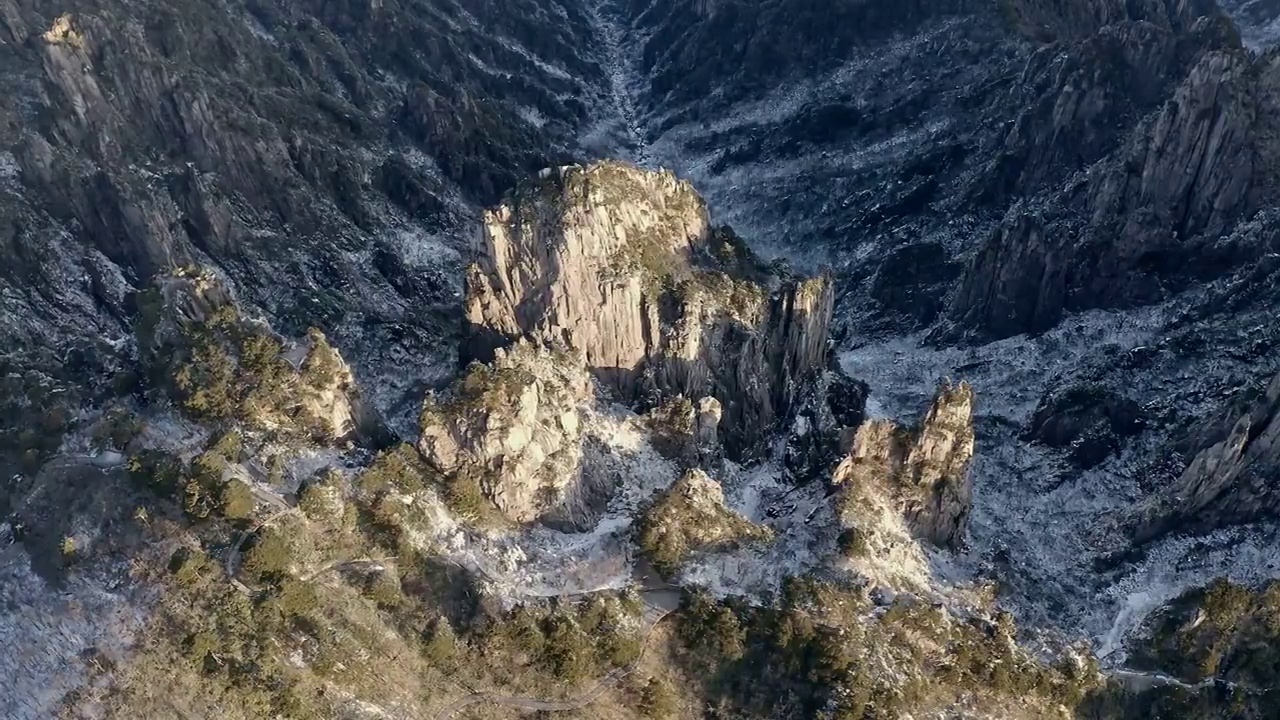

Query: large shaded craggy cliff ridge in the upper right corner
940 3 1280 338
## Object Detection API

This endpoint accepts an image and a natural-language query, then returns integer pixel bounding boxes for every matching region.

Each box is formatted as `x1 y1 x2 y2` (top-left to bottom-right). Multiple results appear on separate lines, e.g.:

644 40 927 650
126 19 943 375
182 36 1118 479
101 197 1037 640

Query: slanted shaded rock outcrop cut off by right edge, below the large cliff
1134 375 1280 542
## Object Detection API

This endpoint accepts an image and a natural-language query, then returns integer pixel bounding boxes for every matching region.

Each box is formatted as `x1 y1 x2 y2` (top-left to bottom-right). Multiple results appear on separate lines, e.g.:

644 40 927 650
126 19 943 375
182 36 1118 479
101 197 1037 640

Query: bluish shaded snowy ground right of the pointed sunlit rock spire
841 299 1280 665
